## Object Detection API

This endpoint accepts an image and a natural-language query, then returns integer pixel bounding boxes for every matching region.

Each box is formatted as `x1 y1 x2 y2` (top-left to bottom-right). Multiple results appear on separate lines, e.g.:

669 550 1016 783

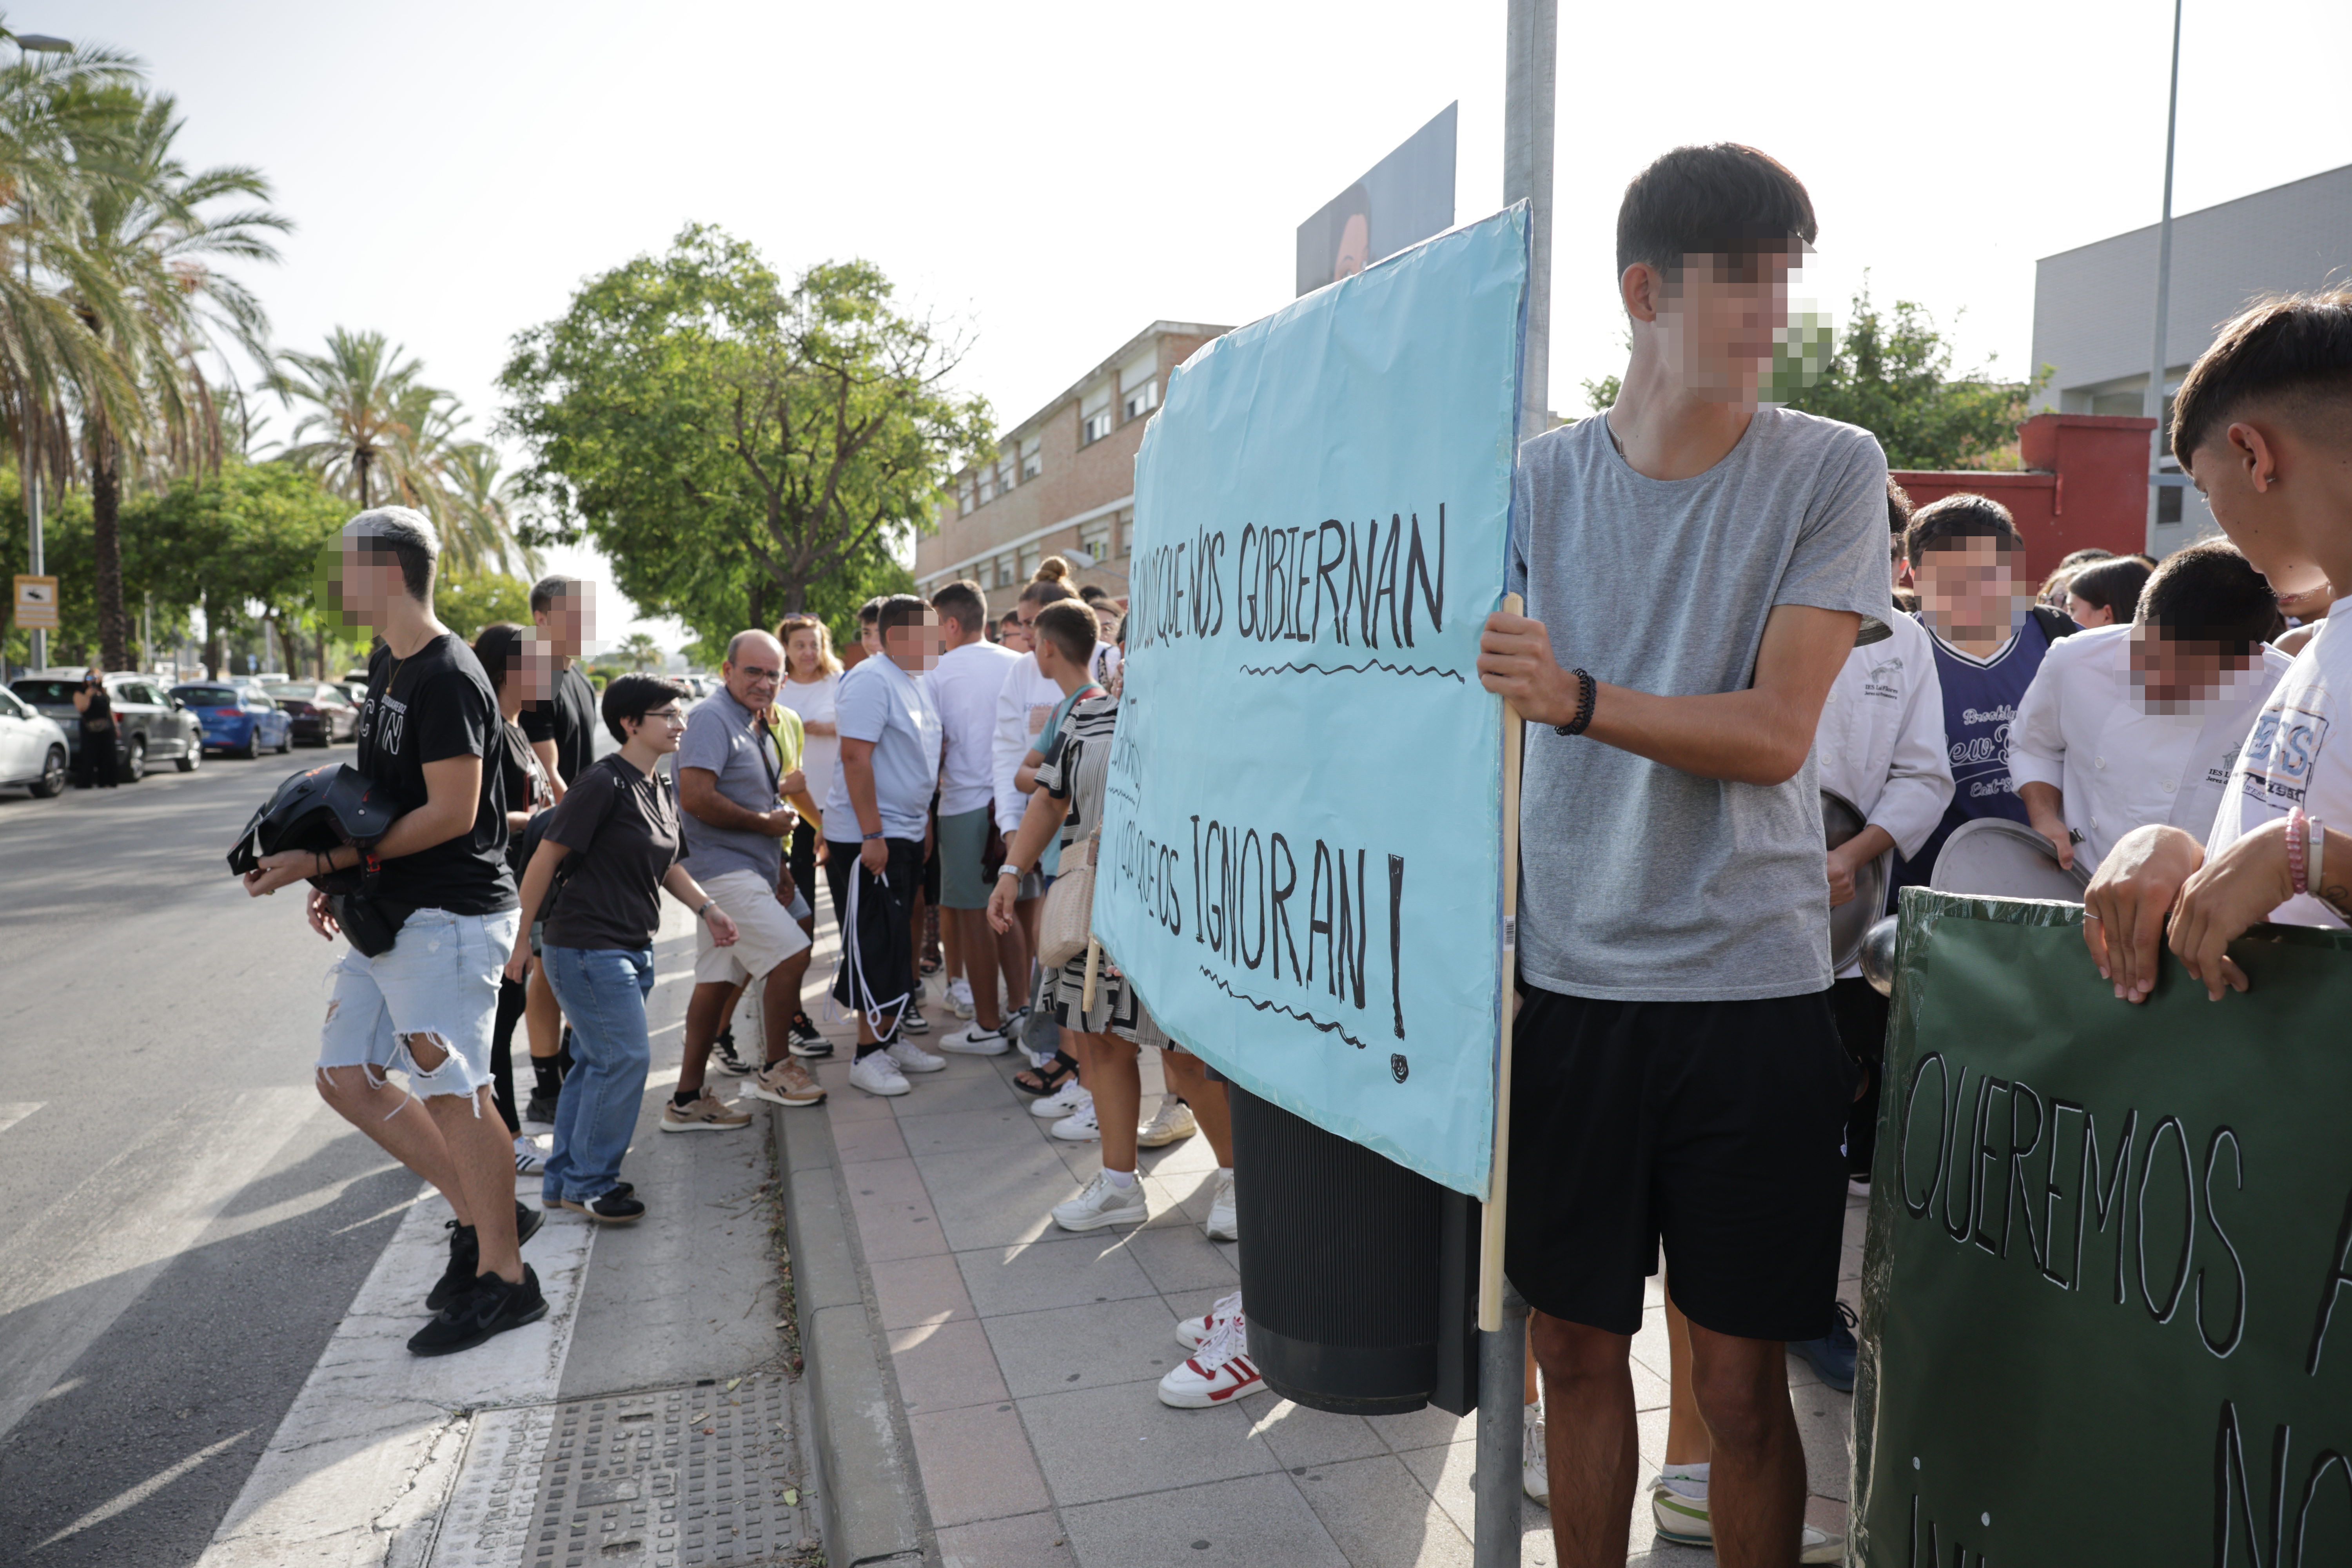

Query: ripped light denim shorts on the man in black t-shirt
318 910 522 1100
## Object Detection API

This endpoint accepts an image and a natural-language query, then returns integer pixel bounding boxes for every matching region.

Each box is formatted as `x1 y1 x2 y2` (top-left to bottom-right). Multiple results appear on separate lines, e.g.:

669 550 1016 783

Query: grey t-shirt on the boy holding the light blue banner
1510 407 1893 1002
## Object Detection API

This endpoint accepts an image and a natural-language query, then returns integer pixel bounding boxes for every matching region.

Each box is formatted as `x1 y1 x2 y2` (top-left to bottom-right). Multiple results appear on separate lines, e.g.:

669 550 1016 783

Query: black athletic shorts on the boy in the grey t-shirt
1505 987 1856 1340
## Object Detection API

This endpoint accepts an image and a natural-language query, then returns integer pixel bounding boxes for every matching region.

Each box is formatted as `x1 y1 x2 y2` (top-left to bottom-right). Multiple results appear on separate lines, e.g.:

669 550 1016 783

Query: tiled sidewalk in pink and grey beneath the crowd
811 955 1863 1568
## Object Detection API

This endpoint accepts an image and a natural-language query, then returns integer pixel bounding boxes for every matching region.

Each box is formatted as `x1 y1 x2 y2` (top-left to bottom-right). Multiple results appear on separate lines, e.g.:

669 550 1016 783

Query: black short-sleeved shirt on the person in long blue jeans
539 752 677 952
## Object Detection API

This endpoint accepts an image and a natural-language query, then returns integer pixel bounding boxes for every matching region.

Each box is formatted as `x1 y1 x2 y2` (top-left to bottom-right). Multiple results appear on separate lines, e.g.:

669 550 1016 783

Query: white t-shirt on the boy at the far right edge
2206 616 2352 926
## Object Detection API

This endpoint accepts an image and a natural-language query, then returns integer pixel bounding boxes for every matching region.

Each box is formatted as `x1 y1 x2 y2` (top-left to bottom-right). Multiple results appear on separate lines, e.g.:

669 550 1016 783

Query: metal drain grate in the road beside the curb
433 1375 814 1568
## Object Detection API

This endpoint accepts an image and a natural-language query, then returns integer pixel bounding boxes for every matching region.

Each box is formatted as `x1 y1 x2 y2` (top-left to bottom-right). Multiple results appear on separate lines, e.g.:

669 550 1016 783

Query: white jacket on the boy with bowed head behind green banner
2009 625 2288 872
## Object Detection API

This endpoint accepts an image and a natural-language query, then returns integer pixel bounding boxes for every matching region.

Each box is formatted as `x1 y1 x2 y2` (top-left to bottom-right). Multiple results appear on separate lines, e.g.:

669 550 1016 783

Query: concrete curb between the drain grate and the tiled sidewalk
769 1105 941 1568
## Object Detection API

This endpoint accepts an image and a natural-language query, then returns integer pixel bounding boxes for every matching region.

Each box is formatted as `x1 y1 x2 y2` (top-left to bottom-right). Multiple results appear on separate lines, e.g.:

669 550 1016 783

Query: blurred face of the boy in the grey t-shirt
1623 245 1804 407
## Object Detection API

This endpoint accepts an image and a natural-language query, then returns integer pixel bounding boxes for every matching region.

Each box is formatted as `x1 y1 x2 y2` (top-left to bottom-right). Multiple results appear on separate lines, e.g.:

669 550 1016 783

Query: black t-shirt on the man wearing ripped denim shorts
353 632 517 915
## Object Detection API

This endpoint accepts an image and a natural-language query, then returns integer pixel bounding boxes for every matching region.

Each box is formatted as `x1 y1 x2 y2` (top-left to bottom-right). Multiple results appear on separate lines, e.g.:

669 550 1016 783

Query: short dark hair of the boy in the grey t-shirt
1618 141 1818 280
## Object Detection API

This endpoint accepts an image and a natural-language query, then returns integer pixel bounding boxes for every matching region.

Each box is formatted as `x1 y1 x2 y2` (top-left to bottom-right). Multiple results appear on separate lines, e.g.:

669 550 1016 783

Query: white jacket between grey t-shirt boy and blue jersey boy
1813 609 1952 978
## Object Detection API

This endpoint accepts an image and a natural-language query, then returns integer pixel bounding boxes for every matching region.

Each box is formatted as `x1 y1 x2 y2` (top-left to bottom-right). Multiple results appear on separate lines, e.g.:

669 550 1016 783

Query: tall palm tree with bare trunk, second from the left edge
66 87 292 668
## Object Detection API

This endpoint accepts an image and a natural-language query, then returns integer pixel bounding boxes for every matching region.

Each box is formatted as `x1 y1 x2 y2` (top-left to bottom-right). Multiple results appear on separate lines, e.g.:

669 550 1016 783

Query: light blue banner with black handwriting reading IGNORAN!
1094 207 1526 1196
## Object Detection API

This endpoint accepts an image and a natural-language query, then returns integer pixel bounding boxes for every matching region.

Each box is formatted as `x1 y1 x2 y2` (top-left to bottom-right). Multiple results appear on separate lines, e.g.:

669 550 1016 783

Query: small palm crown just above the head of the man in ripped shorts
270 327 454 510
